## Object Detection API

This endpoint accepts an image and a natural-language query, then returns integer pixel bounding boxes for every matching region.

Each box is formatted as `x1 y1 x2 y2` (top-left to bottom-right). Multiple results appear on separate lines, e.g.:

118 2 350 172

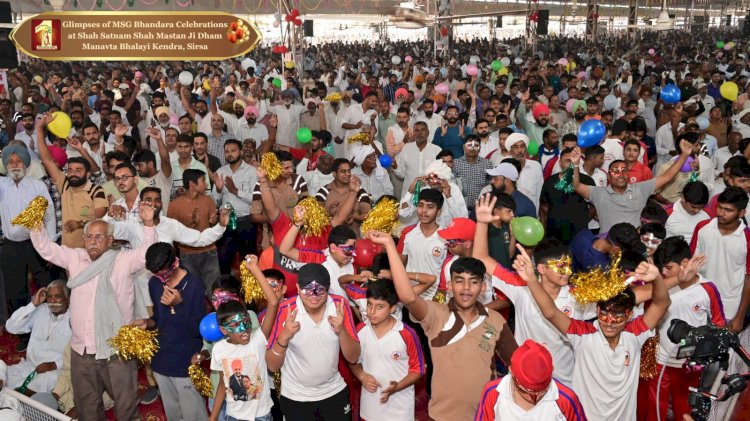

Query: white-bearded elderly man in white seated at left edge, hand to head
0 280 71 396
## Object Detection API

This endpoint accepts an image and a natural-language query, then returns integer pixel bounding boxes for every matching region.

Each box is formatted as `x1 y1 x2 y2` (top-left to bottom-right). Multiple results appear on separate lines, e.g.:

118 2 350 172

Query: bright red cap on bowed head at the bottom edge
510 339 552 392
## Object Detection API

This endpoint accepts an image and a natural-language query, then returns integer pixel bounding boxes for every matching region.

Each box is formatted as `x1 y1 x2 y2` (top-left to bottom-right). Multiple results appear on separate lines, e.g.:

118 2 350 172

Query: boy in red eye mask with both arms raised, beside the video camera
513 240 670 421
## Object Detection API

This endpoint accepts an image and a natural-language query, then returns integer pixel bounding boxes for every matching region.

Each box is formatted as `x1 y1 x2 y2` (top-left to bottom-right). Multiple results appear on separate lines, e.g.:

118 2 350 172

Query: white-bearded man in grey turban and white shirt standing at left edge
0 145 56 322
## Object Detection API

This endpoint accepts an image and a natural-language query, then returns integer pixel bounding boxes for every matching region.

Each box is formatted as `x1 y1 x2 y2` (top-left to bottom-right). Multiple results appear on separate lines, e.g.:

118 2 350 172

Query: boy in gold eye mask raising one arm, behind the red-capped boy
474 197 596 385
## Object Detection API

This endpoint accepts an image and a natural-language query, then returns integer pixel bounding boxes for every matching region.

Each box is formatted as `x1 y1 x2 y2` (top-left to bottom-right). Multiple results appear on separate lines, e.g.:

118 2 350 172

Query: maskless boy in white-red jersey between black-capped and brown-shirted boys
352 279 425 421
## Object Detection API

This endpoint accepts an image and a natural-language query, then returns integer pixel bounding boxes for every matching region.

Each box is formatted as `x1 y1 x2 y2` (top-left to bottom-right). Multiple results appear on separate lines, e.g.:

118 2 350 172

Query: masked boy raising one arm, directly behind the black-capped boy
279 206 357 297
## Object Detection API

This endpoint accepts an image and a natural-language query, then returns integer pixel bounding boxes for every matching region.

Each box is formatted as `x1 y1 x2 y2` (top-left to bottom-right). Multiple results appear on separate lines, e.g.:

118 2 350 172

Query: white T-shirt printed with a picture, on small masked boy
211 329 273 420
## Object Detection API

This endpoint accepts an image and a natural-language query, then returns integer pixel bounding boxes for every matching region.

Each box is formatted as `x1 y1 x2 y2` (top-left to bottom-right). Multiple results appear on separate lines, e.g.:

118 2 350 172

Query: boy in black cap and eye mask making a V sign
266 263 360 421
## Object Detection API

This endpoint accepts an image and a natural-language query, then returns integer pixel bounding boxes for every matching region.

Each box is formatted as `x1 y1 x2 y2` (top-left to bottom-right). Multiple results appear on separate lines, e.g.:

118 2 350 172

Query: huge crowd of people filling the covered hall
0 24 750 421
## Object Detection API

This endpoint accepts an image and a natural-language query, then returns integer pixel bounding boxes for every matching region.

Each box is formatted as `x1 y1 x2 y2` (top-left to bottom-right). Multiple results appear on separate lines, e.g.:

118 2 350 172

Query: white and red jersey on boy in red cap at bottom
474 376 588 421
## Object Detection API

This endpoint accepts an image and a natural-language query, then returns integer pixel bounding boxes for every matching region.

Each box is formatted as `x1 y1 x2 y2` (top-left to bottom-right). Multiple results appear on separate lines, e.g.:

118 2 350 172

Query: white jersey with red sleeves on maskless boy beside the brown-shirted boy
357 319 425 421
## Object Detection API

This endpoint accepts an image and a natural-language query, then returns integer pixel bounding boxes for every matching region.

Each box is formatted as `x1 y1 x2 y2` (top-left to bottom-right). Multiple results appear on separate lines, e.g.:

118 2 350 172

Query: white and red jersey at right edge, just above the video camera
690 218 750 320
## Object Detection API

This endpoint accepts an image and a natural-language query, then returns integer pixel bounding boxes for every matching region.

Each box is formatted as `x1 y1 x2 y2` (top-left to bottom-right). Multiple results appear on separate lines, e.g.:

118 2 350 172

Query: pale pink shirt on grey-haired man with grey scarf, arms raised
31 227 156 355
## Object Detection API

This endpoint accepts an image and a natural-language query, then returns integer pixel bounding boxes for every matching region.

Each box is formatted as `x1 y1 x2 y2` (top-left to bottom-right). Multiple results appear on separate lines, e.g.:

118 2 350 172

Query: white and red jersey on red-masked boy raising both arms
567 316 655 421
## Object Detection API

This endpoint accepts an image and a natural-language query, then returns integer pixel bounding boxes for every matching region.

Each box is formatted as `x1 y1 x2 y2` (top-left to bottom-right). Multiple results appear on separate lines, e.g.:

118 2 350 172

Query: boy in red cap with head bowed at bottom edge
474 339 586 421
